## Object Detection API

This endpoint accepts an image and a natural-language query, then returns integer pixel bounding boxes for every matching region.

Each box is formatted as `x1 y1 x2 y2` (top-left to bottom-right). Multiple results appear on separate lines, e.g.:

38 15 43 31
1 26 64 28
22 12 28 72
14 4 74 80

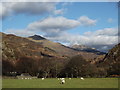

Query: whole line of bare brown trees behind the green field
2 55 117 78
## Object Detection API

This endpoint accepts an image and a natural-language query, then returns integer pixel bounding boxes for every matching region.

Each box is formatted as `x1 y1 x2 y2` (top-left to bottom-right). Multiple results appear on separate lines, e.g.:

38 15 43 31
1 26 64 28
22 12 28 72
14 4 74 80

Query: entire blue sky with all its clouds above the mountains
0 2 118 51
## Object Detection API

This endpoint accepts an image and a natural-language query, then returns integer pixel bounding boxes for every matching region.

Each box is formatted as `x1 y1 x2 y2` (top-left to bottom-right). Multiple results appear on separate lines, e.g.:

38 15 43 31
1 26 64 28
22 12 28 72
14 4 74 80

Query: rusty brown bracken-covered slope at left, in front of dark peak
1 33 63 61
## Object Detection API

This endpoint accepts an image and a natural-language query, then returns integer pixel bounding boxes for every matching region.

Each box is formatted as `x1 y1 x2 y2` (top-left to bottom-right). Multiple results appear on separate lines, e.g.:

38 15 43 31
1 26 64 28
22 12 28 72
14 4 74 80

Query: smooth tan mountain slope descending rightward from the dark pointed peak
27 35 99 60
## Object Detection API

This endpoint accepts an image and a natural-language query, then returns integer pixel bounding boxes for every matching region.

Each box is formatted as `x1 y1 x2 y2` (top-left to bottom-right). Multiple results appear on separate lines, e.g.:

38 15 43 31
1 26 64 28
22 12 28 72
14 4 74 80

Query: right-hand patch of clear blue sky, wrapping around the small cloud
64 2 118 33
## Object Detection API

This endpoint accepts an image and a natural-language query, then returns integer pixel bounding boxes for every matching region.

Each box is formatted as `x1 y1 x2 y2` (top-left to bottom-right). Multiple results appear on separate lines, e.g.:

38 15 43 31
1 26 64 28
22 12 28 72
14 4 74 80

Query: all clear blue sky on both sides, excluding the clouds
3 2 118 34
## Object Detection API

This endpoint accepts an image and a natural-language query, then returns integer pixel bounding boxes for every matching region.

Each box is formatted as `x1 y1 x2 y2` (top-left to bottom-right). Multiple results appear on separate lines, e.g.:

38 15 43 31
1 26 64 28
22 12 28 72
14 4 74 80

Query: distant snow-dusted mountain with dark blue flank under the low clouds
71 45 106 55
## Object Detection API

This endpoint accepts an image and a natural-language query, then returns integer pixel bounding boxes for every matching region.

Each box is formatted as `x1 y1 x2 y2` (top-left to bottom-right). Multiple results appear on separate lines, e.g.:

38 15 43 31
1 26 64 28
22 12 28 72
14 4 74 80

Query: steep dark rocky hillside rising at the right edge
97 43 120 76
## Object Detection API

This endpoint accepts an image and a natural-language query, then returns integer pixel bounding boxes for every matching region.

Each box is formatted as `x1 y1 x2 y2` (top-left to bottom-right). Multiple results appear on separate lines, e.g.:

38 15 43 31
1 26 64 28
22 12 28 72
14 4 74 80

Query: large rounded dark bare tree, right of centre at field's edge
61 55 88 77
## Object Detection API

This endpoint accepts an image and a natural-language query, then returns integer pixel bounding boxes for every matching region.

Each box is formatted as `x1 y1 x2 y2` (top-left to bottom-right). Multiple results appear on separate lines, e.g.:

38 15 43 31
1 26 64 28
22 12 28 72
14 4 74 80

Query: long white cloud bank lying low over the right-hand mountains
47 28 118 51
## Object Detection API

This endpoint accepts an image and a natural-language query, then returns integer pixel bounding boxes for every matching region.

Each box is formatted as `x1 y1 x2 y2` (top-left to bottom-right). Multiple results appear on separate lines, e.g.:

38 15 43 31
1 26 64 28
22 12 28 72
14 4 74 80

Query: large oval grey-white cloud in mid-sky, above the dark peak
27 16 80 33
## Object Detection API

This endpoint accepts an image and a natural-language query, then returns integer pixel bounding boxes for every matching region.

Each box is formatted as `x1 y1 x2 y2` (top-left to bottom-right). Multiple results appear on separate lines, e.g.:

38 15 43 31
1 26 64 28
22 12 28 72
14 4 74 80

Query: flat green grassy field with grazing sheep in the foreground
2 78 118 88
